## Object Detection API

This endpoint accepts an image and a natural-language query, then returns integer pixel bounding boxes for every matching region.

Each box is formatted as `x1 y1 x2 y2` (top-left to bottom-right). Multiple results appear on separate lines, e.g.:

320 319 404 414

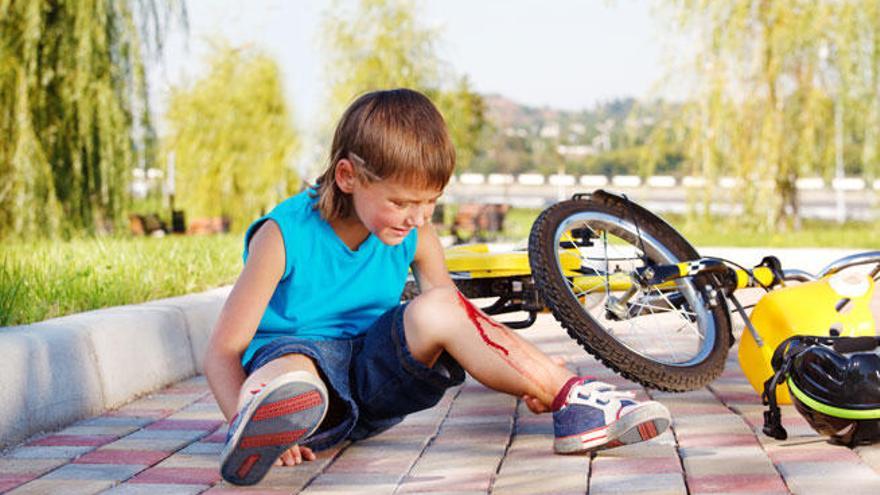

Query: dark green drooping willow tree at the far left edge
0 0 185 238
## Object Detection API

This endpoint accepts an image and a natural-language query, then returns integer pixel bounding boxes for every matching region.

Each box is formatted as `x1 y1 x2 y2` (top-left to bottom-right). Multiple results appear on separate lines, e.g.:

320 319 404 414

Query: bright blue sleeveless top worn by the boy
242 190 418 363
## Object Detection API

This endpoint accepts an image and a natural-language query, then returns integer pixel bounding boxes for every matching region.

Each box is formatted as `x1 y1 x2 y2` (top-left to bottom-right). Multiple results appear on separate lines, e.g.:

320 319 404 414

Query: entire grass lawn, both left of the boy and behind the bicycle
6 205 880 326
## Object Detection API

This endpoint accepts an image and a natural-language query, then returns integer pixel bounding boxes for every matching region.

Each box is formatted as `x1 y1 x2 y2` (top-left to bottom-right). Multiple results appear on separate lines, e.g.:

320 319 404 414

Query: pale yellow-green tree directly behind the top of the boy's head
323 0 486 172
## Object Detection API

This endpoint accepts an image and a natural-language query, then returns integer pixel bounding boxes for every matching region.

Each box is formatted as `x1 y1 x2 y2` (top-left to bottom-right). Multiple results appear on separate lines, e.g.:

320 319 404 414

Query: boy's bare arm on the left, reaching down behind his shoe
204 220 285 420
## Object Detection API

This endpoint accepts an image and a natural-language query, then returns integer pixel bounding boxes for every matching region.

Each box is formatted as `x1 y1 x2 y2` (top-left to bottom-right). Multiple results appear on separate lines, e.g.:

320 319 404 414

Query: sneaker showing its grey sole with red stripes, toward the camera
220 371 327 485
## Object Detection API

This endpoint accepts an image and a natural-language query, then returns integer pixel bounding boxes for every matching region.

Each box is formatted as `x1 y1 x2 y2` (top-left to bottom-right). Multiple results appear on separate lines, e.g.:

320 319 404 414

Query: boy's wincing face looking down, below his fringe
352 180 443 246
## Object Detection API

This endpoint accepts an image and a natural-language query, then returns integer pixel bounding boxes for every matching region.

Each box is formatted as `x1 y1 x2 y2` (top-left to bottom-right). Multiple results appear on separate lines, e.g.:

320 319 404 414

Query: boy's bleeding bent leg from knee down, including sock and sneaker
404 288 670 454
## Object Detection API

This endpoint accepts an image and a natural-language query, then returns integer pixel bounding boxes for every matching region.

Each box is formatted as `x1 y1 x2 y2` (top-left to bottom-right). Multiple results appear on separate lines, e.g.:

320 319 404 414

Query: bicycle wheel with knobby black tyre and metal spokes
529 191 732 391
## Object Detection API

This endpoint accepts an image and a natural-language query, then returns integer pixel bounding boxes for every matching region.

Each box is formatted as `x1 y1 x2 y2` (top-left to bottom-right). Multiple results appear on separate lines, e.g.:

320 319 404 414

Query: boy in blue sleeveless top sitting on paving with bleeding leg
205 89 669 485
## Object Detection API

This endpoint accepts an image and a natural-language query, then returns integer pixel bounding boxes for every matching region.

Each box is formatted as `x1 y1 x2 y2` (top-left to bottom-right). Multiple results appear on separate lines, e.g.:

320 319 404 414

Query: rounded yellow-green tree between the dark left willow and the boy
162 45 299 229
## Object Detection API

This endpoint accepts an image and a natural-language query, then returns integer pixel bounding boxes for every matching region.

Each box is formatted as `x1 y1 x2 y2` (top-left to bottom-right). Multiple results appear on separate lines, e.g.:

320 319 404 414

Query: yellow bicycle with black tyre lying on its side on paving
408 190 880 403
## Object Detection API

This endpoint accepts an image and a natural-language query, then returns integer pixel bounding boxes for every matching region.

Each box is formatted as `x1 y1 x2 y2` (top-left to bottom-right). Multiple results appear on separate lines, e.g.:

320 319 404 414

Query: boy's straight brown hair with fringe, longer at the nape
312 88 455 221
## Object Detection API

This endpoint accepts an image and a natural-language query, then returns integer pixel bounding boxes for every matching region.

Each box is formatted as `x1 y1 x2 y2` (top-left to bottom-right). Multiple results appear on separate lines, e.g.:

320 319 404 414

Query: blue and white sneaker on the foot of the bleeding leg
553 378 670 454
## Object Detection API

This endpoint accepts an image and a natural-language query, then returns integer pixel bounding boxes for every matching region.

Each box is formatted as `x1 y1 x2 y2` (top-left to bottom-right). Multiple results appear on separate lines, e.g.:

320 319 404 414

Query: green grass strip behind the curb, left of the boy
0 234 242 326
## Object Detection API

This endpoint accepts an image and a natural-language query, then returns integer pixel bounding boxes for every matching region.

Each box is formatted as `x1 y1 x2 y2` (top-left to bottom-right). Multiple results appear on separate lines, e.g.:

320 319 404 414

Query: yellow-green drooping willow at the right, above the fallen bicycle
665 0 880 228
